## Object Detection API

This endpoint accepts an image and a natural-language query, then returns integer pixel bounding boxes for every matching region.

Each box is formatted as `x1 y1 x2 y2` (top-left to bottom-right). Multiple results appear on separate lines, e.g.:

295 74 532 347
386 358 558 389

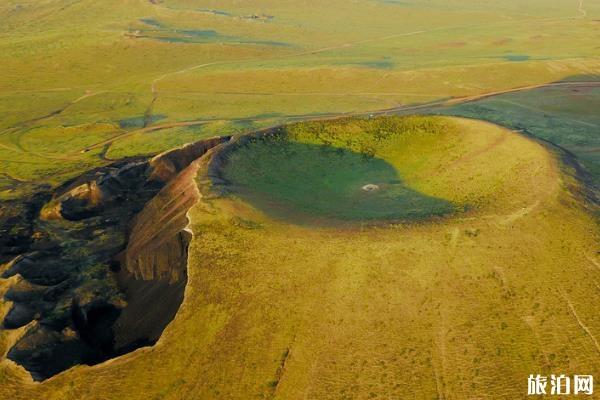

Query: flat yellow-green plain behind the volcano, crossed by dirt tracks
0 0 600 203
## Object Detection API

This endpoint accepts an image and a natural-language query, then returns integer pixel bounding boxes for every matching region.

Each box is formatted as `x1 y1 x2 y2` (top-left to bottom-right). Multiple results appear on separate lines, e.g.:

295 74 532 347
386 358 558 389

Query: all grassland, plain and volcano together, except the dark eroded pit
0 0 600 400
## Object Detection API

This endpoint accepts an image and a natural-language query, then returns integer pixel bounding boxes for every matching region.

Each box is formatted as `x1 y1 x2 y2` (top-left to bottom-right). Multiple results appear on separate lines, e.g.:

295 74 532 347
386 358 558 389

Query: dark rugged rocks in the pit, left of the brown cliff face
0 155 159 380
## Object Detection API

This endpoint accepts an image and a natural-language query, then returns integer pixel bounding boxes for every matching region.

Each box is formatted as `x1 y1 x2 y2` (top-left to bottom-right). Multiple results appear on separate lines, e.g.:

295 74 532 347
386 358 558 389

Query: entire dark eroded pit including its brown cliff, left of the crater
0 138 228 380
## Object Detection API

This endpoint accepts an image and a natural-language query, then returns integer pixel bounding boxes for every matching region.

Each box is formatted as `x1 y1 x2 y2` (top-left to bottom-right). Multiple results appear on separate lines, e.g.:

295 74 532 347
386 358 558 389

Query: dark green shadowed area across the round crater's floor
220 134 457 225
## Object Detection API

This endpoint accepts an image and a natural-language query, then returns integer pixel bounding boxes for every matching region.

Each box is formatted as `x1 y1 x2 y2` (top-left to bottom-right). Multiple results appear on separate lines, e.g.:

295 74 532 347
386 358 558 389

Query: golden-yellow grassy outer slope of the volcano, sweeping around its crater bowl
0 119 600 399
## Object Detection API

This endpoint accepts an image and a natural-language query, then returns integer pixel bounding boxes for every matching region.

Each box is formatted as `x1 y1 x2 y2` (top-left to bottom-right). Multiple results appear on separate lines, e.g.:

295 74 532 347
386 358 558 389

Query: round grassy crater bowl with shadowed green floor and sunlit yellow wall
223 117 510 222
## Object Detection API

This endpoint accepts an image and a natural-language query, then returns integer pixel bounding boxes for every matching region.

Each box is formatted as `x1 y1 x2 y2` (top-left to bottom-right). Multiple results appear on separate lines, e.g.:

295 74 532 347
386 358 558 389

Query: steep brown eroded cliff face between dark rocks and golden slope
113 138 226 348
